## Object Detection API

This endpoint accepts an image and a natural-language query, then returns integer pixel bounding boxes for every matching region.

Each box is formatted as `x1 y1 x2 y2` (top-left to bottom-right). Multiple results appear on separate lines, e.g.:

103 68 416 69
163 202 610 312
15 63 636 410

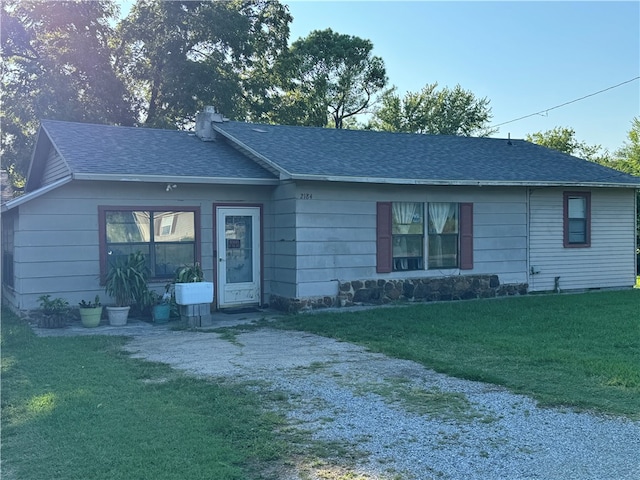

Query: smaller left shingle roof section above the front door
42 120 275 180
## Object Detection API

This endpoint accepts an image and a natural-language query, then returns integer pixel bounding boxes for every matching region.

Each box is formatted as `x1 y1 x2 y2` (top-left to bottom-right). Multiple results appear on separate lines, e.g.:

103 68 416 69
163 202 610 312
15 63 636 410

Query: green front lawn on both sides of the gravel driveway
1 290 640 480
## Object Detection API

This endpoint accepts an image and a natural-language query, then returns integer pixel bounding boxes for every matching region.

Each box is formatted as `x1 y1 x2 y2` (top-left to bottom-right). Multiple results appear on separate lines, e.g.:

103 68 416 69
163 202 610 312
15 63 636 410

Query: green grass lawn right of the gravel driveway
270 290 640 419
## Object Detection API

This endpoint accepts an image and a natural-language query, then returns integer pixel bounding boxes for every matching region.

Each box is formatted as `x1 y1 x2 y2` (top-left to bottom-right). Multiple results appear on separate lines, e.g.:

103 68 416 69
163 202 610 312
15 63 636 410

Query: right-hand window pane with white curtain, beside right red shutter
428 202 459 268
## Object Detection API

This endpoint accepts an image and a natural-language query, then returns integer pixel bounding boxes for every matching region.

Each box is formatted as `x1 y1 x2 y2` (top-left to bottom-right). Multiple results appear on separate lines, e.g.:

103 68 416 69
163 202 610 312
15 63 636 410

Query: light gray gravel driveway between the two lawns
37 316 640 480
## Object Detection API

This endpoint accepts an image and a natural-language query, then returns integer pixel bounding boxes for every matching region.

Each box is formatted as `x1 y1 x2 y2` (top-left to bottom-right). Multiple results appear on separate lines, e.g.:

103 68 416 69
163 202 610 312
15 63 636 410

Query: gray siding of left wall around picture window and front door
15 181 273 310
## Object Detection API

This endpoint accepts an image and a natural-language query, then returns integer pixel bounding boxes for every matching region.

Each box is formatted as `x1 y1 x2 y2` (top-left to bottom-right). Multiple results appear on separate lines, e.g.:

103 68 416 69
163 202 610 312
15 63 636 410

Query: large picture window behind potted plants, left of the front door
99 207 199 278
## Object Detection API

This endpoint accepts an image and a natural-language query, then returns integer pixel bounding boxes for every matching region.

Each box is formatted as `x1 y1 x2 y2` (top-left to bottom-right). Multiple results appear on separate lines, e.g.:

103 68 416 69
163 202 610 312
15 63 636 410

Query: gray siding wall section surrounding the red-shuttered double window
295 183 528 298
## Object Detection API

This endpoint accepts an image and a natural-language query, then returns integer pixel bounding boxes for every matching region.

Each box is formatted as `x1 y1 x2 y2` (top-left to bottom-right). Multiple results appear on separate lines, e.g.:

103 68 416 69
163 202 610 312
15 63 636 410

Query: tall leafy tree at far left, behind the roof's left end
0 0 135 185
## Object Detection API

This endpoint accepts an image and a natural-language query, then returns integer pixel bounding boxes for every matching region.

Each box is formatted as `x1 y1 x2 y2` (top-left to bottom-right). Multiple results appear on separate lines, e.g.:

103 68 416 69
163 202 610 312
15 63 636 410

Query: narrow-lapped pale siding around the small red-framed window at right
529 189 636 291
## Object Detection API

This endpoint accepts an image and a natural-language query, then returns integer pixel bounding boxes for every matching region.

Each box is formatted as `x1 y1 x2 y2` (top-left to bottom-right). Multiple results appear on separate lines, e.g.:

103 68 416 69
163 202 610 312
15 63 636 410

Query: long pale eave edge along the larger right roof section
291 174 640 189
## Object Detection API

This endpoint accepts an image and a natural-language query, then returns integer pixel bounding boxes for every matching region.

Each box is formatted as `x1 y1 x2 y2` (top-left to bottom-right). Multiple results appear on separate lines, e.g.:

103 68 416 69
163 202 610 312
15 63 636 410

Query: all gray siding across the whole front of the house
12 181 635 310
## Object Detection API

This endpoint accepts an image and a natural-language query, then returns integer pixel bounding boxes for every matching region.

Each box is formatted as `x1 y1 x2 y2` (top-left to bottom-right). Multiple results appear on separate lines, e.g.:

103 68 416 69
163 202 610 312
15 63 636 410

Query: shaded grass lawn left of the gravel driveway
2 311 288 480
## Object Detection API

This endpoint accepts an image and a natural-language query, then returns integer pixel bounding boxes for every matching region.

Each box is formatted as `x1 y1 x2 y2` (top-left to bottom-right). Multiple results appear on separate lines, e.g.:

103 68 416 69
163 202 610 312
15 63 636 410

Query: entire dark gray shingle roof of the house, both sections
36 120 640 186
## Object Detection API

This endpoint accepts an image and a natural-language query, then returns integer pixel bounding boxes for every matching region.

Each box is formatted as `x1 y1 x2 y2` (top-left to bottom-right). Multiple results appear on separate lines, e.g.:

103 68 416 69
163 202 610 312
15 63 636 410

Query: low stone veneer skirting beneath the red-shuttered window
270 275 529 313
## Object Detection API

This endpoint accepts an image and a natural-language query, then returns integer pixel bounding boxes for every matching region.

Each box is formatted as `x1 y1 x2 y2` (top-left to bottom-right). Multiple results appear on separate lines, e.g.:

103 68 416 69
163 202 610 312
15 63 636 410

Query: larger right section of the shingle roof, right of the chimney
214 122 640 185
